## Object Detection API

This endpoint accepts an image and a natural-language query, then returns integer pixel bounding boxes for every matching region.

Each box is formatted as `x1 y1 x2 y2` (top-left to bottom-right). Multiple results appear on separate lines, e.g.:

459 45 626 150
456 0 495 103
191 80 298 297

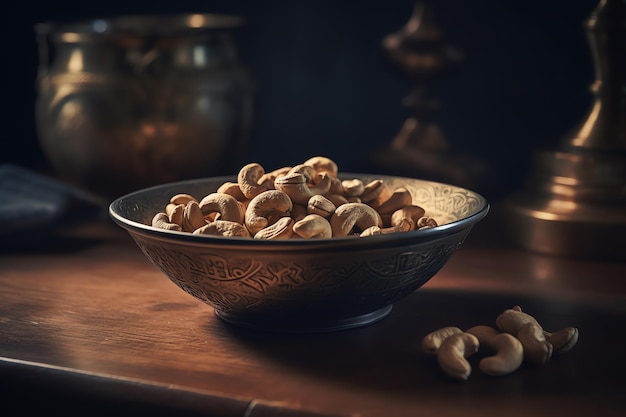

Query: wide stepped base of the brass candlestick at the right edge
505 152 626 259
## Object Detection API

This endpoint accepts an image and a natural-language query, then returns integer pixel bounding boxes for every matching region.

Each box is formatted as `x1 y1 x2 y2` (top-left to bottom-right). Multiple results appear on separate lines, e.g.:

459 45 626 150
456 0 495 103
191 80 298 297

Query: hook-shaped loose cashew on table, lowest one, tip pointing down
437 332 480 380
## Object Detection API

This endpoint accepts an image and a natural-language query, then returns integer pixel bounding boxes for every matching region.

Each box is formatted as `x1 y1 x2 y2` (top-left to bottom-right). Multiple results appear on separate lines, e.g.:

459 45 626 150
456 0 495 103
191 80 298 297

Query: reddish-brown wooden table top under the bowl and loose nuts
0 208 626 417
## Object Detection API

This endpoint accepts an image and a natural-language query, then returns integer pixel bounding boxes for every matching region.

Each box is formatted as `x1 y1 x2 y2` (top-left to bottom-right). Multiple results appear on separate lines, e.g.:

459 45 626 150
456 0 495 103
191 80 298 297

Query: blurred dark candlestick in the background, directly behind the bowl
368 0 487 188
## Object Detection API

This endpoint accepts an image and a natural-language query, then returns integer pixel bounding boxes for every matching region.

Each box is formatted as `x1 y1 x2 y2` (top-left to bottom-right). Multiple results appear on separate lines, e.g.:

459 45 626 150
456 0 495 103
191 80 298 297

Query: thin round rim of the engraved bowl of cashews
108 172 491 250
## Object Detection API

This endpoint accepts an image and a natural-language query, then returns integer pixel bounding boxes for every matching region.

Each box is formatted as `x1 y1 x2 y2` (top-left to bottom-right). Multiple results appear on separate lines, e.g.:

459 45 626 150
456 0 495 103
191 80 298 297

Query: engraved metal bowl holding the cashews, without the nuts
109 173 489 332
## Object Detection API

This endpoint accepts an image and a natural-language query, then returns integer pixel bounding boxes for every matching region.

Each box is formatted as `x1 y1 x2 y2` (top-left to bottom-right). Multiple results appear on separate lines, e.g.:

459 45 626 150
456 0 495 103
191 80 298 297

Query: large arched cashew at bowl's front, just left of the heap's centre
244 190 293 236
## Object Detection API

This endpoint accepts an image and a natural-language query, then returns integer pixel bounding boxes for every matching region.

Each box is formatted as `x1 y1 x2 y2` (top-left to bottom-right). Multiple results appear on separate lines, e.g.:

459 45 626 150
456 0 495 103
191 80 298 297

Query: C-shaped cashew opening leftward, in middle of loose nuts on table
466 326 524 376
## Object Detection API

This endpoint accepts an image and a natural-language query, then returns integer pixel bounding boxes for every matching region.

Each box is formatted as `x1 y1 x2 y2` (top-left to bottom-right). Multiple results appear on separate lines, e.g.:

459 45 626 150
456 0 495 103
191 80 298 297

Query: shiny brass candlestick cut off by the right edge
505 0 626 259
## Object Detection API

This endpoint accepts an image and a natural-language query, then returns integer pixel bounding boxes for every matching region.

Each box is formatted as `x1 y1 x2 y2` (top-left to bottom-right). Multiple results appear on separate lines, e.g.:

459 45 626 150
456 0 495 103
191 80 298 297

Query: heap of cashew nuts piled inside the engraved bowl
152 156 437 239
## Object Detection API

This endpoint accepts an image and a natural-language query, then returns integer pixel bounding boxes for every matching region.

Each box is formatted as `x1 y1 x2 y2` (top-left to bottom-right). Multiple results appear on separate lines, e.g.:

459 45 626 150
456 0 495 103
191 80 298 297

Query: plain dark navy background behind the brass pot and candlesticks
0 0 598 199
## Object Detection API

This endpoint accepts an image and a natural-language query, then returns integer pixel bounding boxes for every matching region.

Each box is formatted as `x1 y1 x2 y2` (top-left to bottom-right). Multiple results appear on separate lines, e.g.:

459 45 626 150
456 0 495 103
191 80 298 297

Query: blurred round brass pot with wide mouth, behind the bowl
35 14 253 197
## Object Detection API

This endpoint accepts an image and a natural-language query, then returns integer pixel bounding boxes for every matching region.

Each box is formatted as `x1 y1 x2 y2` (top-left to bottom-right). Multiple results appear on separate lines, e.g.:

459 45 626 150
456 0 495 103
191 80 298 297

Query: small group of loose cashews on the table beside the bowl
422 306 578 380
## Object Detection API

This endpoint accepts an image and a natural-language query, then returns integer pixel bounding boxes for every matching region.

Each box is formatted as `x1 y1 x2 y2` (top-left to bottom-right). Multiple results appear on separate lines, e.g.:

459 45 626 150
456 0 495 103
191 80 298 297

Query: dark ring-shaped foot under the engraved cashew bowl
215 305 393 333
